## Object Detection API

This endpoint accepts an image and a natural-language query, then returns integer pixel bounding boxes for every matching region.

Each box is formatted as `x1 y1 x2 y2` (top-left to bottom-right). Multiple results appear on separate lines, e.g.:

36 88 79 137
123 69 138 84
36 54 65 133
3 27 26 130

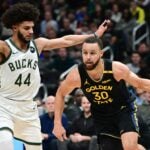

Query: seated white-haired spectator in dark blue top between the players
40 96 68 150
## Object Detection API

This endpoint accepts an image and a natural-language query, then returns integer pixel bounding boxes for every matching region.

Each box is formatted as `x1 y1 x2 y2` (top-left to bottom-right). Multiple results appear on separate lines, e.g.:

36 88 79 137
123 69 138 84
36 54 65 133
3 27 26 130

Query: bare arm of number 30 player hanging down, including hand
53 68 80 141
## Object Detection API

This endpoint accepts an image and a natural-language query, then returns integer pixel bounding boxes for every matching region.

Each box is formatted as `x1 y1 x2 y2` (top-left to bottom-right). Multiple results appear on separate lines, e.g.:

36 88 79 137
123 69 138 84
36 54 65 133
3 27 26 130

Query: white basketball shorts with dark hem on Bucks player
0 96 42 145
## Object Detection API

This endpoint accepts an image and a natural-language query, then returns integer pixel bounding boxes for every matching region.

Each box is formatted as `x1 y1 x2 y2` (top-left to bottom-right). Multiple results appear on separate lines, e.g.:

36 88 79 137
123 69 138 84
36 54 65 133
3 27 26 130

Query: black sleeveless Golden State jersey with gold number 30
78 59 135 117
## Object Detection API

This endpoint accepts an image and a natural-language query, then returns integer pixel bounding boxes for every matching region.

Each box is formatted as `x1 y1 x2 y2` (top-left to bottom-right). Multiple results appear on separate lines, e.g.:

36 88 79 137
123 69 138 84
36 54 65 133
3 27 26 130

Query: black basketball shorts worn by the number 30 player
95 108 139 138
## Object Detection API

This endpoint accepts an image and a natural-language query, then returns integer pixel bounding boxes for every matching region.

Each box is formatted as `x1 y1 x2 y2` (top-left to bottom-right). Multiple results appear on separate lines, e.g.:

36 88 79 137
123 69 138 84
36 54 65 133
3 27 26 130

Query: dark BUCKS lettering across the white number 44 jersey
8 59 38 71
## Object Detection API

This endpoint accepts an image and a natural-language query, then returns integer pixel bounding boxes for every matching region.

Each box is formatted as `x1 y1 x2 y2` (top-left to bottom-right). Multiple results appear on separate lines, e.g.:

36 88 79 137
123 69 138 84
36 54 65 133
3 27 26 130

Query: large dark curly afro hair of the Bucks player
2 3 40 28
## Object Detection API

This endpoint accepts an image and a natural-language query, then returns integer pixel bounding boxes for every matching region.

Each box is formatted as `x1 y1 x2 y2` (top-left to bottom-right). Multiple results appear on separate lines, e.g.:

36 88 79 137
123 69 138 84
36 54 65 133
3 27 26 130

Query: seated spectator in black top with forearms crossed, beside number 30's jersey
68 96 96 150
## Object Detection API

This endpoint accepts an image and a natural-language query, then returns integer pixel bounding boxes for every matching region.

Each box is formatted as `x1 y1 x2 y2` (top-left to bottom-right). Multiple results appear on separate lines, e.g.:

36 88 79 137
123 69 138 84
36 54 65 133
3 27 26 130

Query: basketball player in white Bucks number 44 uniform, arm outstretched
0 3 109 150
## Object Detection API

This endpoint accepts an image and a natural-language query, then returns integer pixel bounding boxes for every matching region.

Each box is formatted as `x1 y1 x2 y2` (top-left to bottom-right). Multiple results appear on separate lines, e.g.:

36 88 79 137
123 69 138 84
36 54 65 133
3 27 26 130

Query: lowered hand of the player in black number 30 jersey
53 124 67 141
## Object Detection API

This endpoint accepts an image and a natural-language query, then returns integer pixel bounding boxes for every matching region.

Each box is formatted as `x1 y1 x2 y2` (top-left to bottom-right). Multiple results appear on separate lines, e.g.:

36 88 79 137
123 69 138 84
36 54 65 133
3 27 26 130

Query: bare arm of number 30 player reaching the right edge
113 62 150 92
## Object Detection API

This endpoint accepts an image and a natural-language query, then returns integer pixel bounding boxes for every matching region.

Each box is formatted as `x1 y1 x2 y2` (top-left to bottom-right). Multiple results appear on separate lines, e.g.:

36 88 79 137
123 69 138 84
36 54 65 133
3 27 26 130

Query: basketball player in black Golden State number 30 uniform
53 37 150 150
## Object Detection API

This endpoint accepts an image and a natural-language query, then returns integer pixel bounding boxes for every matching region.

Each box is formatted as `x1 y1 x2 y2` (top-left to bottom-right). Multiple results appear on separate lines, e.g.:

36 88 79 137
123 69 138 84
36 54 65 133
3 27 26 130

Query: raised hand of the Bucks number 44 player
95 19 111 37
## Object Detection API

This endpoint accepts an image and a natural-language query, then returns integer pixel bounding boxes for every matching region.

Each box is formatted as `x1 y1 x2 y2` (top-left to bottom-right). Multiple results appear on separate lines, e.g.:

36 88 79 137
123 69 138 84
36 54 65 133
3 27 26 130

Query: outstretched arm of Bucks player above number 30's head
35 20 110 52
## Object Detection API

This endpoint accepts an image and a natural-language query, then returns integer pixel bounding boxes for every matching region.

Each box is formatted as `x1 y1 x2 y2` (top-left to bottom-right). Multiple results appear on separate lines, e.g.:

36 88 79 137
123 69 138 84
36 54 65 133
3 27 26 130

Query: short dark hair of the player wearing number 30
84 36 103 49
